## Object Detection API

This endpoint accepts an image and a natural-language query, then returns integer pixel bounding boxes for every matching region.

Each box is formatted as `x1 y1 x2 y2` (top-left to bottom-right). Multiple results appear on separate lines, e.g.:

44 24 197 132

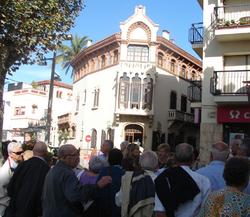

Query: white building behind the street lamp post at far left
3 80 72 146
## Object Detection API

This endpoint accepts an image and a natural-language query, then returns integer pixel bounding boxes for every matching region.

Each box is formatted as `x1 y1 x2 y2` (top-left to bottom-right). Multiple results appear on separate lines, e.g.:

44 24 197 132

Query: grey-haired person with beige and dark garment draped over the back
116 151 158 216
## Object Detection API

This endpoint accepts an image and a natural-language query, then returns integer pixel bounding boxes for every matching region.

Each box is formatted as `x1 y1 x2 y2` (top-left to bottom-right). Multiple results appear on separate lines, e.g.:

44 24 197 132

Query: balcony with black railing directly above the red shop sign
210 70 250 102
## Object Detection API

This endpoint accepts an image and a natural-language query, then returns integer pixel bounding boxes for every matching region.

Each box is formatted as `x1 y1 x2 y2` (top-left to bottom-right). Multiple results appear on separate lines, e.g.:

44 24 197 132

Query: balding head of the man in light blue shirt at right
211 141 229 161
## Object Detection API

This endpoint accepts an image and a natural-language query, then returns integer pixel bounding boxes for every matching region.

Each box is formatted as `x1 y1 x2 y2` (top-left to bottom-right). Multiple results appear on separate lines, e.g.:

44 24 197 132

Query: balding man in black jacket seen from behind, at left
4 142 49 217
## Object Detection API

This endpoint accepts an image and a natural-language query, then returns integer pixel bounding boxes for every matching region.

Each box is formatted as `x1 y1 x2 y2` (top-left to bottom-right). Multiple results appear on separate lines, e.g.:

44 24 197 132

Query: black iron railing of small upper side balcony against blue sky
188 22 204 44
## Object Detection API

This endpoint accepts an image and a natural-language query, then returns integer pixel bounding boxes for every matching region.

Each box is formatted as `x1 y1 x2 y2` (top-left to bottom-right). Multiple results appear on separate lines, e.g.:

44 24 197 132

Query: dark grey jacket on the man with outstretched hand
43 161 97 217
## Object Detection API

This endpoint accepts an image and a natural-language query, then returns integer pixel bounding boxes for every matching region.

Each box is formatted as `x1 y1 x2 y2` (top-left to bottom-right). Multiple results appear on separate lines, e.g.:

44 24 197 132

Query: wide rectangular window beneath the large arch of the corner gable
127 45 149 62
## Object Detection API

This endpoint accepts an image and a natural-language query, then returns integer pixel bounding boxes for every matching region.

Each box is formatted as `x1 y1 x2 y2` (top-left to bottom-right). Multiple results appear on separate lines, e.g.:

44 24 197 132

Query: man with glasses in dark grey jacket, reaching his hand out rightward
43 144 112 217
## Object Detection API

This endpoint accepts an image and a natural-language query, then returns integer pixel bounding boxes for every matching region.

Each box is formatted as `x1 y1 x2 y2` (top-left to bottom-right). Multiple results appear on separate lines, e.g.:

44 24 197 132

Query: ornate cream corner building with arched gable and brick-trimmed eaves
72 6 202 149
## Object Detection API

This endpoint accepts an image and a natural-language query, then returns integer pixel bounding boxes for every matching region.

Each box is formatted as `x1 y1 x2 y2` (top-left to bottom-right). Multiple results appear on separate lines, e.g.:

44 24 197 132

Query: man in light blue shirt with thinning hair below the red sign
196 142 230 191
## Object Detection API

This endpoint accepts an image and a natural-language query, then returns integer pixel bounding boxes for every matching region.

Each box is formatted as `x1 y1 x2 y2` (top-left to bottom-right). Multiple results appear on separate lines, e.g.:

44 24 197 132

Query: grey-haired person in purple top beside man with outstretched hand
79 156 107 185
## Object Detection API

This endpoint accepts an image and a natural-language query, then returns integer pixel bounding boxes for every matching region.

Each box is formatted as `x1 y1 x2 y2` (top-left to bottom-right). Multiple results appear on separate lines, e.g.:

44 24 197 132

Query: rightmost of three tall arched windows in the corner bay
142 75 153 110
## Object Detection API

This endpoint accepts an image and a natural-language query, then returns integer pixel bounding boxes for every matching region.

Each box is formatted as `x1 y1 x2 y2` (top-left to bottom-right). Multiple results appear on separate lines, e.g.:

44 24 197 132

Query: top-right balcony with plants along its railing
212 4 250 42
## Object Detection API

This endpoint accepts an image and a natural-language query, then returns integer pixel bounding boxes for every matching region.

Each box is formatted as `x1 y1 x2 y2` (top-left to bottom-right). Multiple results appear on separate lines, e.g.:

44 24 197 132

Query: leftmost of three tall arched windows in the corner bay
119 72 130 108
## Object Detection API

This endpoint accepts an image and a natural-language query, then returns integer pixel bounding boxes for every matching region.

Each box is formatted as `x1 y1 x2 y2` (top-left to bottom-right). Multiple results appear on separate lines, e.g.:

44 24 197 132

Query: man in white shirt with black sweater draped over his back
154 143 211 217
